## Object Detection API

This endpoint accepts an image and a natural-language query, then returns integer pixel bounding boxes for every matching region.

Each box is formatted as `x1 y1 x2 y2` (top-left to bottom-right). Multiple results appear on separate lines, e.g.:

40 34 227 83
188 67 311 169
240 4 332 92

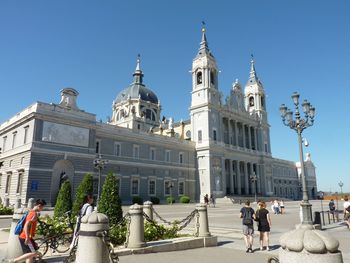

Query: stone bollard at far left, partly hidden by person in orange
7 208 27 258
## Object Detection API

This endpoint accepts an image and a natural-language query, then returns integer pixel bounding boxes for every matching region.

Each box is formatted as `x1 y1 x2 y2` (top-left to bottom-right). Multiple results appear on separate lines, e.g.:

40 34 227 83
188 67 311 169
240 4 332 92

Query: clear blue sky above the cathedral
0 0 350 192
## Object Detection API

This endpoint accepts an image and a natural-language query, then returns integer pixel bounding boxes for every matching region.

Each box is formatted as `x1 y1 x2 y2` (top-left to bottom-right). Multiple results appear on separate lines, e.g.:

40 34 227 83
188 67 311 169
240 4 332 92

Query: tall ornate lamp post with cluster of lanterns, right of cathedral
280 92 315 225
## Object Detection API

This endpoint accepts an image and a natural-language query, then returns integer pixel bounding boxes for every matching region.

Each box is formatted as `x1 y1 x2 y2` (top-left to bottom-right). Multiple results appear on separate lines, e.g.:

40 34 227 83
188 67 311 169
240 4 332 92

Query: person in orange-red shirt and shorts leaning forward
8 199 46 263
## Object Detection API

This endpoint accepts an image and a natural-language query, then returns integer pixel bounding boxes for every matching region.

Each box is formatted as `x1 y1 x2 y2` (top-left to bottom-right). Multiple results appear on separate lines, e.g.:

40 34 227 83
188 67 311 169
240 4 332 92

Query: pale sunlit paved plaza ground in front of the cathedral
0 201 350 263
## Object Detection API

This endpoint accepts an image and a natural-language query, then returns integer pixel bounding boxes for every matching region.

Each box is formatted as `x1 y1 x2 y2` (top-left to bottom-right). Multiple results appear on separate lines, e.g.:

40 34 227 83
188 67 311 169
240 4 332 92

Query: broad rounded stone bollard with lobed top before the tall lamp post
279 225 343 263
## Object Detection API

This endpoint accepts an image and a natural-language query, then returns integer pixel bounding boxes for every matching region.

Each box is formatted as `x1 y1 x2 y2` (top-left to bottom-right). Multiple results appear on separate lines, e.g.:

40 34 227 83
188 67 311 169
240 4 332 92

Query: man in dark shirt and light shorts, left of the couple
239 201 255 253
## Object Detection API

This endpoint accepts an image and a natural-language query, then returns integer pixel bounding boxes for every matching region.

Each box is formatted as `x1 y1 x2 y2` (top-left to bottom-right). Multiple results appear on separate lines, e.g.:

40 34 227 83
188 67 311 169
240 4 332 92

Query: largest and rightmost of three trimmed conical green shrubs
97 173 123 225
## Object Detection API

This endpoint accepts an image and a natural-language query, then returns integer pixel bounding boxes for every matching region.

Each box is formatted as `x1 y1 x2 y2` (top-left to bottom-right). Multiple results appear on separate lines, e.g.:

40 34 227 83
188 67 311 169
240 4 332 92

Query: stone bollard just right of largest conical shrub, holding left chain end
126 204 146 248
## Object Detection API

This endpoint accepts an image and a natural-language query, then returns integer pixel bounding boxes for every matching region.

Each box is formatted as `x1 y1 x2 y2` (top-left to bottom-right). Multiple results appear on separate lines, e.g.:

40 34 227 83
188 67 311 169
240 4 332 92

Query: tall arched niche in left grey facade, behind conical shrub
50 160 74 206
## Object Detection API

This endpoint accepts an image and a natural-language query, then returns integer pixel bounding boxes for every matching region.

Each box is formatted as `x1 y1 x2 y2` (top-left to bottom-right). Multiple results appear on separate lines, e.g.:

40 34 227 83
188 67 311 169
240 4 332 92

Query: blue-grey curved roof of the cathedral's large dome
115 83 158 104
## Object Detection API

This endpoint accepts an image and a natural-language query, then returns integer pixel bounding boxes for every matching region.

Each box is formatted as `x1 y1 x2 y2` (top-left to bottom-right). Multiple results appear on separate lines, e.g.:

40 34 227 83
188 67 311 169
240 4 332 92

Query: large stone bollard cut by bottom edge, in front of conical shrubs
75 212 110 263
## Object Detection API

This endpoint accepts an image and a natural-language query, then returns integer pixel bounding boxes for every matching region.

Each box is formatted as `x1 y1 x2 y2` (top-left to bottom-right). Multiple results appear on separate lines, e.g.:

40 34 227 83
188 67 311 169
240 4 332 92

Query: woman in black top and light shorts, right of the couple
255 202 271 250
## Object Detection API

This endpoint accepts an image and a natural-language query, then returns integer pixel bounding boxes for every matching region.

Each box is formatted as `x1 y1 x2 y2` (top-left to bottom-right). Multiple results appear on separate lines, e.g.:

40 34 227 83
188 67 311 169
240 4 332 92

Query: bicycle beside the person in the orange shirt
35 211 74 259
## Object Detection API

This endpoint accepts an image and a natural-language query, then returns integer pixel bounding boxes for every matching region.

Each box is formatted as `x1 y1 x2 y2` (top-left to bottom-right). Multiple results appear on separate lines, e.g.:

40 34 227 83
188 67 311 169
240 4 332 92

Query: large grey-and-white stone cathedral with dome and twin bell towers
0 28 317 205
